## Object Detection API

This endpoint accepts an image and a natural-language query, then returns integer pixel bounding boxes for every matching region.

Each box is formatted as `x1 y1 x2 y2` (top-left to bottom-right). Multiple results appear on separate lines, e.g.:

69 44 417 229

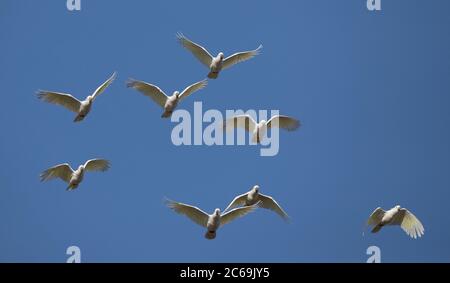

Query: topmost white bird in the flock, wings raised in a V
177 33 262 79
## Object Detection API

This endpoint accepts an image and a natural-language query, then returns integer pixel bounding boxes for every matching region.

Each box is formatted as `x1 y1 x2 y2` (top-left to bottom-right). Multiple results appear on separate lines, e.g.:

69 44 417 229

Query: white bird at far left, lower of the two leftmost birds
41 159 110 191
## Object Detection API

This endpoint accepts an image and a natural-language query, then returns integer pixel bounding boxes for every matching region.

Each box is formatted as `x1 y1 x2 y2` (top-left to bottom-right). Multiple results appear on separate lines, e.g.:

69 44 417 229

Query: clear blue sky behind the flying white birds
0 0 450 262
